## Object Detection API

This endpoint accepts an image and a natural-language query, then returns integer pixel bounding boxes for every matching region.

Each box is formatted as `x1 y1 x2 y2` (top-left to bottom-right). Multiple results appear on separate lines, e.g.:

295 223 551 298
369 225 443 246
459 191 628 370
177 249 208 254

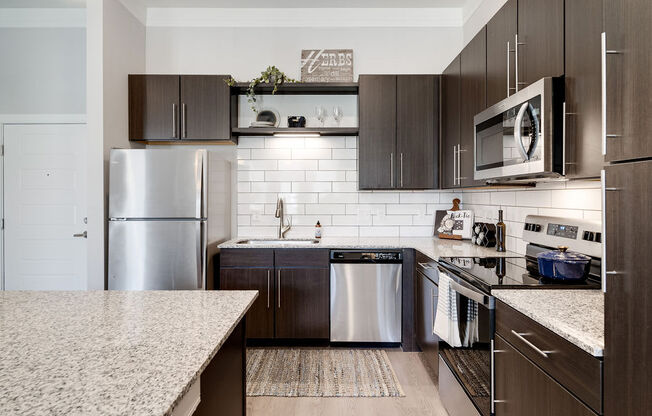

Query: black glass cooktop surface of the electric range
439 256 600 292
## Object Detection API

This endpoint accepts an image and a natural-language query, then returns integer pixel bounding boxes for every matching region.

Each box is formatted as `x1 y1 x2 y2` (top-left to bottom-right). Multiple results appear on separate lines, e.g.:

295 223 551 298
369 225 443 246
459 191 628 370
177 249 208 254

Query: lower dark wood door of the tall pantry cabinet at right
604 161 652 416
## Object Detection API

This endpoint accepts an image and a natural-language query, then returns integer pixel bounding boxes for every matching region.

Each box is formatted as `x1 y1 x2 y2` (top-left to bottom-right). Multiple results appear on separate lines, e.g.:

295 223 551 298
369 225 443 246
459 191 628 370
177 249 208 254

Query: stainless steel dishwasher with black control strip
330 250 403 343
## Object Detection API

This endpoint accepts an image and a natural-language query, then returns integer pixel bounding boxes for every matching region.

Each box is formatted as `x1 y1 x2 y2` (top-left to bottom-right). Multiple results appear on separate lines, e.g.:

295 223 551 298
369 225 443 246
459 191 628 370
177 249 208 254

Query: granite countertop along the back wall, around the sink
218 237 517 260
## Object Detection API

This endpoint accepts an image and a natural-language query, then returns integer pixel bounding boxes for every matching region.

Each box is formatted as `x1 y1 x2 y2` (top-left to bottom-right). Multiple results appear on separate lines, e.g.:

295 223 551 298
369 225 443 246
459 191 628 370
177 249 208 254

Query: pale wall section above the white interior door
0 27 86 114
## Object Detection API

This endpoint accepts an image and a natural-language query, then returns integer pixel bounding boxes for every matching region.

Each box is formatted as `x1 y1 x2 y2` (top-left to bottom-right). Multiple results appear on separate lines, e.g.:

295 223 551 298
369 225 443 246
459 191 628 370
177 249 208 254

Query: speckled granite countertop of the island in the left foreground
0 291 258 416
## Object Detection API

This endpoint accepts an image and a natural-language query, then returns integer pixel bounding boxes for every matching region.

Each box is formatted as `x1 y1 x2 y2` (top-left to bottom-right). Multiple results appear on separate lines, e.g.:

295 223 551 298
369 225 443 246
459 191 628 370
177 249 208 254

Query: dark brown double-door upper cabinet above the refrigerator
129 75 234 141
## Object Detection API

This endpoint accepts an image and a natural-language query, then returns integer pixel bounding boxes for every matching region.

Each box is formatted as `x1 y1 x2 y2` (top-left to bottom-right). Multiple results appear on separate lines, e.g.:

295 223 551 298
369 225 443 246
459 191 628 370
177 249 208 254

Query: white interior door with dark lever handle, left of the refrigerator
3 124 87 290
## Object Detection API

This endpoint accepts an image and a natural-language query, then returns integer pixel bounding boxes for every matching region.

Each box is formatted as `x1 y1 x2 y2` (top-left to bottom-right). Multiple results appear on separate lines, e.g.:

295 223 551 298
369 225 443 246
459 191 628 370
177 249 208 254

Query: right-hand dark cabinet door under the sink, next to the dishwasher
275 268 330 338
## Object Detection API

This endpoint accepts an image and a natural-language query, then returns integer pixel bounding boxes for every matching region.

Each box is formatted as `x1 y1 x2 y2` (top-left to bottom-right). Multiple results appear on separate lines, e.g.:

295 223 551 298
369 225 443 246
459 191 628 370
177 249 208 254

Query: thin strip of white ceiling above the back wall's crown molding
130 0 474 8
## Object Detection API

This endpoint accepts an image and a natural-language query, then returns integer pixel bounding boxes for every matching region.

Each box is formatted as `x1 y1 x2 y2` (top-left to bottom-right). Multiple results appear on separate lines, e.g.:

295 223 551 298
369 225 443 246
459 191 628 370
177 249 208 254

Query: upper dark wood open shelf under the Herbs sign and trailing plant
231 82 358 95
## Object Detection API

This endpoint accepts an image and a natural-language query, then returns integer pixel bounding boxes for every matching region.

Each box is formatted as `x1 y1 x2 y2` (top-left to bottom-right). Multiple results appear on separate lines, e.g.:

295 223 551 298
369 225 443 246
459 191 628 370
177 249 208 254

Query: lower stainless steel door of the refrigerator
109 220 206 290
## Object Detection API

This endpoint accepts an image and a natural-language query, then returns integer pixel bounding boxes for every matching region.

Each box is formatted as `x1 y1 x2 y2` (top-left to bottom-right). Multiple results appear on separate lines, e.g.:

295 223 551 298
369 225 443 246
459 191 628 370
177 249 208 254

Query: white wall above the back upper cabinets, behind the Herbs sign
147 27 462 80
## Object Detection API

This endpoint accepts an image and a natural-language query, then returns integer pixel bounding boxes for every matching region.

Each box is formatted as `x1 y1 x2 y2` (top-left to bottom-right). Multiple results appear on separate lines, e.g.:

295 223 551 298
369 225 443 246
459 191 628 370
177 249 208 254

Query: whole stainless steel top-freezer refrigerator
108 149 229 290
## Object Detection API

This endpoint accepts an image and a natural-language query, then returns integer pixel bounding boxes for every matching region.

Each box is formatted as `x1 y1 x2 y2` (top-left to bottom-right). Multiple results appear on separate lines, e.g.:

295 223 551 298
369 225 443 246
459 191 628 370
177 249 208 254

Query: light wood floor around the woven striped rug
247 350 448 416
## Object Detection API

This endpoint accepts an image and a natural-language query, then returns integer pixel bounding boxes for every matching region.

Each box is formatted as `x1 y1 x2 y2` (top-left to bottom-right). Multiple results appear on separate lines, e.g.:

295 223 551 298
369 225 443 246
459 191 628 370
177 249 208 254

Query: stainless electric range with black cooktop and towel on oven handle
436 215 602 416
